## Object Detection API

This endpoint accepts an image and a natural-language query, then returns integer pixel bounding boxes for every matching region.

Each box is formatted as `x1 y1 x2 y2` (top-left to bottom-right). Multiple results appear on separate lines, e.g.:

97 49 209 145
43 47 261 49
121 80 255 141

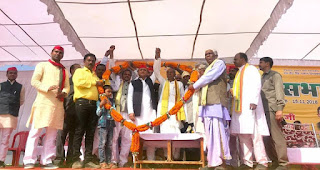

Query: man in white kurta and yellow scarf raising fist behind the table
153 49 185 159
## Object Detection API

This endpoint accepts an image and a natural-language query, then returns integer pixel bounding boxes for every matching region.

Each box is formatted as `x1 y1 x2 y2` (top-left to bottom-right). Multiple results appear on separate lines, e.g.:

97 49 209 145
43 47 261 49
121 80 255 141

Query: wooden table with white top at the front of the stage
134 133 205 168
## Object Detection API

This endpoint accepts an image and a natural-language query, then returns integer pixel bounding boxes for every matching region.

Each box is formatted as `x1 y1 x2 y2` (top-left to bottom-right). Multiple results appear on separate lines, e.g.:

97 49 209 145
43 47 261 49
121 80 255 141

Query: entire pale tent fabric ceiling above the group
0 0 320 65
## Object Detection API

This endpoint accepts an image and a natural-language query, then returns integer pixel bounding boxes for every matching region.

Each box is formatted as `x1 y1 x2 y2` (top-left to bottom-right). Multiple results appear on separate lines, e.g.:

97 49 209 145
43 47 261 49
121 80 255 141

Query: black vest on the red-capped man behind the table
131 77 157 116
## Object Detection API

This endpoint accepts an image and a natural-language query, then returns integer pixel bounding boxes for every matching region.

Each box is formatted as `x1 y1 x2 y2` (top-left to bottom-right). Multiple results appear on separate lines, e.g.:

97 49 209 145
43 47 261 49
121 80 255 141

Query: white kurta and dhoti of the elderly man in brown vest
193 60 231 167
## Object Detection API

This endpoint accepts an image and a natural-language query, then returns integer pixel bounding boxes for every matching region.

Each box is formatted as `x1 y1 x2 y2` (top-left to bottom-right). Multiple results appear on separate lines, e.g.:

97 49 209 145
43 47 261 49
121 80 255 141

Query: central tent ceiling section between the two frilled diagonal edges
52 0 278 59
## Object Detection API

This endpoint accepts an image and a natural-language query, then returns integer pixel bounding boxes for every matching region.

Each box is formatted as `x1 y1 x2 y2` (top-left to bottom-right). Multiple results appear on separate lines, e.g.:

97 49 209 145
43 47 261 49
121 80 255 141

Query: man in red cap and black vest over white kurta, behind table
127 65 156 160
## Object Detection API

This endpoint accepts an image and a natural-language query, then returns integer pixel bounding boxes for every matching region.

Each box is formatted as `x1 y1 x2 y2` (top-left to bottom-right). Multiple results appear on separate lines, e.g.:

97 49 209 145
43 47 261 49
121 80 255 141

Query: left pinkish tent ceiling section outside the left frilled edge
0 0 82 63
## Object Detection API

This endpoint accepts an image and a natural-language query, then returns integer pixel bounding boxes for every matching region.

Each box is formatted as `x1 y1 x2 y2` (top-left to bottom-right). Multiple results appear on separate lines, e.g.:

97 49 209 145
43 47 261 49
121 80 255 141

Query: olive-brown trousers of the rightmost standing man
263 111 288 166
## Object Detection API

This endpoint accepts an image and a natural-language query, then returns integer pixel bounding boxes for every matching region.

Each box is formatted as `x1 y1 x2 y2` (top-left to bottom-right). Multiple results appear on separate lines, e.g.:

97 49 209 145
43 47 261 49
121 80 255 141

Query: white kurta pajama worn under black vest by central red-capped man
127 74 156 160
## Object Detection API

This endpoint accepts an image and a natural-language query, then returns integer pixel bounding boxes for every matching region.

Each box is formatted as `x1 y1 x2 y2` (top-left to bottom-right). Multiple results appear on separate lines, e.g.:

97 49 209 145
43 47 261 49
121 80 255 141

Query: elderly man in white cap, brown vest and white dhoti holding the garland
189 49 231 169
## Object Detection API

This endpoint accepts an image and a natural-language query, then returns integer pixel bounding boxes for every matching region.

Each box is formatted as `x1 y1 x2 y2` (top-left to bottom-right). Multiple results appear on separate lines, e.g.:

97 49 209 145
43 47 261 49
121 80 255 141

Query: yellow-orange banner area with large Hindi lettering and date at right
273 66 320 132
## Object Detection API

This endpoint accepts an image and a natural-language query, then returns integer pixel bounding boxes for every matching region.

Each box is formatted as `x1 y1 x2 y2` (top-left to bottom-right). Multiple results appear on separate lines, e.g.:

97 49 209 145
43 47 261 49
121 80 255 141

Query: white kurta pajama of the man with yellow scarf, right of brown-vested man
231 65 269 167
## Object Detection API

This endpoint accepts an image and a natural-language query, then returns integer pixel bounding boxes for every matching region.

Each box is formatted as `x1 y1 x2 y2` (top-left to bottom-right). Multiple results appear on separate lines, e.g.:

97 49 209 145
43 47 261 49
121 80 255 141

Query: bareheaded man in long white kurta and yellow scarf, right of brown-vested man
231 53 269 169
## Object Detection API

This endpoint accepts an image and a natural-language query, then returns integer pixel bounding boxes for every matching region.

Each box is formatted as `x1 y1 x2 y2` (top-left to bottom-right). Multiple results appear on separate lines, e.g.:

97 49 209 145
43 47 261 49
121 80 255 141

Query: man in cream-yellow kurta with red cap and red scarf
23 46 70 169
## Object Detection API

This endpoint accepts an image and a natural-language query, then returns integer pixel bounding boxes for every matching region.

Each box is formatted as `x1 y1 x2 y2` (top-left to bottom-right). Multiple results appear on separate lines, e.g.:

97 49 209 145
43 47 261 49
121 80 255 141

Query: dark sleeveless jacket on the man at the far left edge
0 80 22 117
